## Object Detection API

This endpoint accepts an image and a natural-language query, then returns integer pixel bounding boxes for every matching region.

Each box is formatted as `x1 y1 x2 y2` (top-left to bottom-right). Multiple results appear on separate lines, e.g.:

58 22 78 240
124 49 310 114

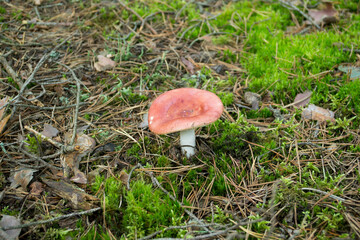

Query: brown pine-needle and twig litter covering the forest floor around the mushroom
0 1 360 239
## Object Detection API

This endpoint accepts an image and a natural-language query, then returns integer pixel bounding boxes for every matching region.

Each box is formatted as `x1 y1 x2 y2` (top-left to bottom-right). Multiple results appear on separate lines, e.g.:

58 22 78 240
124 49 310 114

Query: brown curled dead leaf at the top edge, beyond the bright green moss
309 2 339 24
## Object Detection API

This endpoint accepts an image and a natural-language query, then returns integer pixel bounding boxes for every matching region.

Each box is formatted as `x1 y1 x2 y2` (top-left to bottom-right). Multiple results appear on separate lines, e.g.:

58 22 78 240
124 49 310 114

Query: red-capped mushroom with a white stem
148 88 224 157
